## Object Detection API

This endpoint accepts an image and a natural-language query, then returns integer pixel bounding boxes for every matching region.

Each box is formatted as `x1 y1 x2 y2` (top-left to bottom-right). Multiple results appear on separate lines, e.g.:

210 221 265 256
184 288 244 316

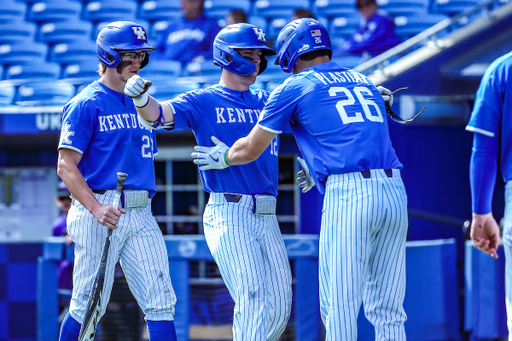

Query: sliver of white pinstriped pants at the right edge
503 181 512 341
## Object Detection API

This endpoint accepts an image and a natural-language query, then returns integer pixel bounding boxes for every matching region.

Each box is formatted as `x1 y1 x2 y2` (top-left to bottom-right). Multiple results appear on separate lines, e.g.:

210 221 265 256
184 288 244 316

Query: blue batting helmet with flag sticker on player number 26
276 18 332 72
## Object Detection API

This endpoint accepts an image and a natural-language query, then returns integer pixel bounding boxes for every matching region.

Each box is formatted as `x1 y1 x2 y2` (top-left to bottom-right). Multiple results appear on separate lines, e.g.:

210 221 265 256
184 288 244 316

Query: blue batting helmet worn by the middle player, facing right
213 24 276 77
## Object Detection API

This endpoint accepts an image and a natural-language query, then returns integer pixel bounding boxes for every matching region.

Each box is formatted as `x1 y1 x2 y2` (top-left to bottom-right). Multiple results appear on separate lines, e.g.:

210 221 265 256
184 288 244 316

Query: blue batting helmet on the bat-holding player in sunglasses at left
96 21 156 69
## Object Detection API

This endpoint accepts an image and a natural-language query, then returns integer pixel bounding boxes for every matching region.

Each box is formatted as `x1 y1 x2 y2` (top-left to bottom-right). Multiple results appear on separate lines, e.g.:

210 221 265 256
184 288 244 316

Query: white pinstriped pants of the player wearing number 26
319 169 408 341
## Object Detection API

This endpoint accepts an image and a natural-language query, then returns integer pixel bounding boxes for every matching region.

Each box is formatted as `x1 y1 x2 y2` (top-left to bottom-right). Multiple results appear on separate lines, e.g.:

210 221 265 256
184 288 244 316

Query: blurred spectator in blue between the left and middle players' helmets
155 0 220 65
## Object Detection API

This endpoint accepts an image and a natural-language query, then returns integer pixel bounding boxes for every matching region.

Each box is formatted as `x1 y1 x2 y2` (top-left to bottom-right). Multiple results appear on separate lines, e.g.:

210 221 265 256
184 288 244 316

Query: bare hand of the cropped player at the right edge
470 212 500 258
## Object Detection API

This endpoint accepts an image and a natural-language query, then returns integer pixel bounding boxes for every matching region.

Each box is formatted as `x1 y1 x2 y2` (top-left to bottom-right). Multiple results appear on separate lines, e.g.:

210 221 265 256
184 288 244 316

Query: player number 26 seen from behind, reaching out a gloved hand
193 18 408 341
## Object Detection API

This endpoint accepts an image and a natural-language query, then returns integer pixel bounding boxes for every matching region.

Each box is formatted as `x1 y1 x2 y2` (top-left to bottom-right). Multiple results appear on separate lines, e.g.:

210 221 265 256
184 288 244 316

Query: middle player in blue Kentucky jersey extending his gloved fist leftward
125 24 292 341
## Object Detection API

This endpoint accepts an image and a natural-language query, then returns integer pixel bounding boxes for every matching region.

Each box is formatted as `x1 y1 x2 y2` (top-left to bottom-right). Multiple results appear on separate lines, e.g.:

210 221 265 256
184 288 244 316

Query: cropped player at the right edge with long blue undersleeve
466 52 512 332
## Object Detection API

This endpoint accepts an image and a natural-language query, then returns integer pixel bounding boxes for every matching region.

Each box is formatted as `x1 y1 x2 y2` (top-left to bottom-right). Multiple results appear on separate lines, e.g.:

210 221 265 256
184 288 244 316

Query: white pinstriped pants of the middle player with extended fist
203 193 292 341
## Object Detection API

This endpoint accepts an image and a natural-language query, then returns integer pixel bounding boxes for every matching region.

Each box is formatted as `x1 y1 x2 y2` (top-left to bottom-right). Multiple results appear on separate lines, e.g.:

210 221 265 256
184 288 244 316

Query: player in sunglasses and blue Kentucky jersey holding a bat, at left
57 21 176 341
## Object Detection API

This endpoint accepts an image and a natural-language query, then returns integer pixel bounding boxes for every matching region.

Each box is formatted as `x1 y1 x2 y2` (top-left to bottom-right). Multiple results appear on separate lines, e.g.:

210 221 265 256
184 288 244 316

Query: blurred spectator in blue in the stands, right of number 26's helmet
341 0 400 60
